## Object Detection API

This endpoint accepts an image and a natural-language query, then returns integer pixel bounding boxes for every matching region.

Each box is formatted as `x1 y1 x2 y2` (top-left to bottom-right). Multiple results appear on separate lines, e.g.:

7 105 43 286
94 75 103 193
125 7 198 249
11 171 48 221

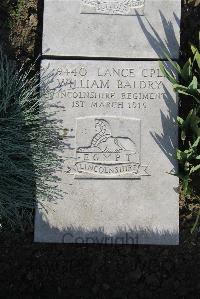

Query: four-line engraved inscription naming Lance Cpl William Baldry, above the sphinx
45 65 166 110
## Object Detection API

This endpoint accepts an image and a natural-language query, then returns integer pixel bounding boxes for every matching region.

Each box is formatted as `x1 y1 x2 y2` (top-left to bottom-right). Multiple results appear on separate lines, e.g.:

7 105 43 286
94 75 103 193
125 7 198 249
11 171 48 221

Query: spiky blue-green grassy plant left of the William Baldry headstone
0 51 62 230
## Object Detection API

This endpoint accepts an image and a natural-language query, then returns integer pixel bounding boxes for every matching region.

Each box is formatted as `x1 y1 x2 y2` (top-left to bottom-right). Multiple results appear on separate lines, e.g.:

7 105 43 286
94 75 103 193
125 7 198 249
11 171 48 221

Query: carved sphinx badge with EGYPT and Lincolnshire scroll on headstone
65 116 149 179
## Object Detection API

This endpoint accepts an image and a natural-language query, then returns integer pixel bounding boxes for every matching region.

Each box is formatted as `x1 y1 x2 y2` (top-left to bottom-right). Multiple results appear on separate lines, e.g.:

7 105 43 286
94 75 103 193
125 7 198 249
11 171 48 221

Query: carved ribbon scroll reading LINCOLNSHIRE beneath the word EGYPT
67 161 149 179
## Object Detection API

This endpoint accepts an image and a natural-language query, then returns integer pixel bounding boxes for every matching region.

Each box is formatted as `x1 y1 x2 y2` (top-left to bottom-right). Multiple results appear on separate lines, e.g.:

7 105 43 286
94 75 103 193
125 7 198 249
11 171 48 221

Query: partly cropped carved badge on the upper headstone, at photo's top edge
81 0 145 15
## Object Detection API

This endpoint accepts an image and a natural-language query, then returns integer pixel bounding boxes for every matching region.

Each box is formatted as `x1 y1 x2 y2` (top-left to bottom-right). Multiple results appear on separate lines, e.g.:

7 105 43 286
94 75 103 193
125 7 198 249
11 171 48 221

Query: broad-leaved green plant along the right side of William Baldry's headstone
160 38 200 231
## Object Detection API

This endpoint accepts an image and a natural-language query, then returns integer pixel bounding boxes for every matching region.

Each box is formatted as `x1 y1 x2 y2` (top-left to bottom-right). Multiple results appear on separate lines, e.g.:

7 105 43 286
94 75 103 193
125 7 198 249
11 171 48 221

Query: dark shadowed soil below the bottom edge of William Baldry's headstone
0 233 200 299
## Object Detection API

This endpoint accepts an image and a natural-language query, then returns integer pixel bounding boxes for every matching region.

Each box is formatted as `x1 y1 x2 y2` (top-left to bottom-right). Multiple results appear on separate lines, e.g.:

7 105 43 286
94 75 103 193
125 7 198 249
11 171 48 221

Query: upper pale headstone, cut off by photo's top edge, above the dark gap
43 0 181 59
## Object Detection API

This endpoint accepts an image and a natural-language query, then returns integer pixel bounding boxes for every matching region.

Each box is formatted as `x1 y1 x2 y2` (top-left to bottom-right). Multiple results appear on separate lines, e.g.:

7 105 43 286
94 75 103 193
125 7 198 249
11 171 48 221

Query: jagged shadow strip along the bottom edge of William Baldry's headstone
35 217 179 245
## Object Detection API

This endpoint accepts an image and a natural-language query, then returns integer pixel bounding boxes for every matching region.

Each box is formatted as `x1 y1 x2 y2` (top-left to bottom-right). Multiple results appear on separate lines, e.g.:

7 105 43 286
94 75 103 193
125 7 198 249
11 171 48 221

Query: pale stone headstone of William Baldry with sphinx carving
35 60 179 244
